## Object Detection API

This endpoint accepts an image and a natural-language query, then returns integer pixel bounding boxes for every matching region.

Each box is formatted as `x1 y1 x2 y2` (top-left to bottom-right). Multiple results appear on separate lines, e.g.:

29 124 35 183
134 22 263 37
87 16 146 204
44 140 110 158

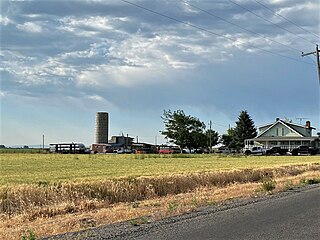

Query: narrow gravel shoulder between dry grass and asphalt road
42 184 320 240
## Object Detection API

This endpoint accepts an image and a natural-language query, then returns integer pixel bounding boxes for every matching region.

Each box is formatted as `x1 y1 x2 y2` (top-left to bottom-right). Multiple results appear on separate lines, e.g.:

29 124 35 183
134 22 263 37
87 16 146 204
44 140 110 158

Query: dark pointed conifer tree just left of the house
233 111 257 149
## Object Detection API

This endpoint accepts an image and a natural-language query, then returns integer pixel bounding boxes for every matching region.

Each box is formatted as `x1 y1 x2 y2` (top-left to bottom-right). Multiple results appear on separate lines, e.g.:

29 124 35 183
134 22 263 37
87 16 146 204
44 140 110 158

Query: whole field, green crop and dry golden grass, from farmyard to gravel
0 153 320 240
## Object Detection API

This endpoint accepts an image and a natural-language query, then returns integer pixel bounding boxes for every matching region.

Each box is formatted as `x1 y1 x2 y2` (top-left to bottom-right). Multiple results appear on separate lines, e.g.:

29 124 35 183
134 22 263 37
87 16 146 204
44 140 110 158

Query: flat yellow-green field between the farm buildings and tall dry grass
0 154 320 186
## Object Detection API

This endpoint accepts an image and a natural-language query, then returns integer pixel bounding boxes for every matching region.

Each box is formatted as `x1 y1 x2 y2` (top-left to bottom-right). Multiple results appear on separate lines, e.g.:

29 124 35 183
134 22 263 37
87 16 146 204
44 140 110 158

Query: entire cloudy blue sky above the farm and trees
0 0 320 146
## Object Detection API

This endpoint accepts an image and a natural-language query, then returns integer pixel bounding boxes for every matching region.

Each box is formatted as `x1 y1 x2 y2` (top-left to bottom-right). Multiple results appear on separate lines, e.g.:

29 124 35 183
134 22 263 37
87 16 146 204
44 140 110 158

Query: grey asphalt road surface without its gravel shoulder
129 187 320 240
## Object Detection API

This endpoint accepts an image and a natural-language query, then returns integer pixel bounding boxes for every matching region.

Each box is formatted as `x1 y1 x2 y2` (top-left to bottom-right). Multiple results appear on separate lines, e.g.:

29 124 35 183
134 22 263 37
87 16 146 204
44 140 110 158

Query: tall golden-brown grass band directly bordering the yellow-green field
0 164 320 219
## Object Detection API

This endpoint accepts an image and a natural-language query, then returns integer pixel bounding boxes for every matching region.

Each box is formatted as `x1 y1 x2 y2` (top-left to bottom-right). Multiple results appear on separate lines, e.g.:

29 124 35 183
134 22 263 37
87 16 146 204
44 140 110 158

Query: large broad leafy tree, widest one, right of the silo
161 110 206 150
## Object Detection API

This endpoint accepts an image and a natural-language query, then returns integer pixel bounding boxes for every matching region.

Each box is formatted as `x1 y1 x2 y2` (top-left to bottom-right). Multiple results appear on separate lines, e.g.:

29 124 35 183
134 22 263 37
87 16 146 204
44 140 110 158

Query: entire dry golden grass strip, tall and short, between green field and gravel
0 164 320 239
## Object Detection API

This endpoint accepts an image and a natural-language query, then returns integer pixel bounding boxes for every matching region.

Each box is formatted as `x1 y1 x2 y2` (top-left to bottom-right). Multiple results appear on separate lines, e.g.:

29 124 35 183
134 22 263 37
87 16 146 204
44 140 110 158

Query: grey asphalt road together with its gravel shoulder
46 184 320 240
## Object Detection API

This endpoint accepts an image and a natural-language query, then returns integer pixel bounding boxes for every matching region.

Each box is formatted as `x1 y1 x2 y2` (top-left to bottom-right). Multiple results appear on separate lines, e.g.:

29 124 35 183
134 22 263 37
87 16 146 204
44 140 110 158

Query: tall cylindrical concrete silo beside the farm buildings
96 112 109 143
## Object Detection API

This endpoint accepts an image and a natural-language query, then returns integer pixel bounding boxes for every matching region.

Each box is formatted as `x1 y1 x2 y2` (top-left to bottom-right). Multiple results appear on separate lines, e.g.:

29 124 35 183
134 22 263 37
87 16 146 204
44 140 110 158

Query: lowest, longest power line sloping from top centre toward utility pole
121 0 313 65
